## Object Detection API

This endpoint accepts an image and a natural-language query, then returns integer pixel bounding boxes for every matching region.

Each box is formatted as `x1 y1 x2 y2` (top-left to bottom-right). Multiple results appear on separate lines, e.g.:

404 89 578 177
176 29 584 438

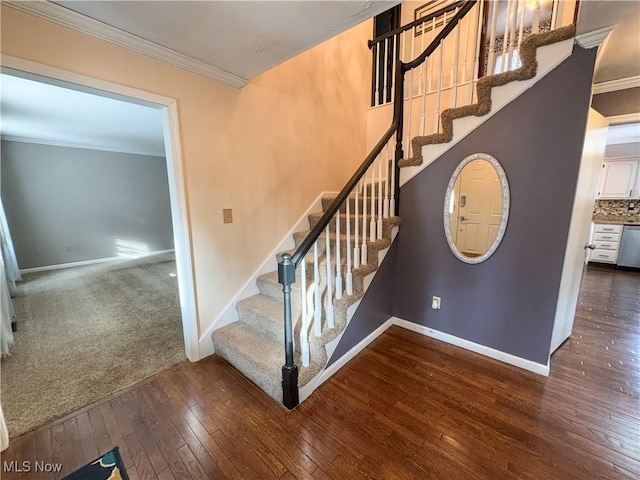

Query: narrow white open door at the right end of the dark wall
549 109 609 355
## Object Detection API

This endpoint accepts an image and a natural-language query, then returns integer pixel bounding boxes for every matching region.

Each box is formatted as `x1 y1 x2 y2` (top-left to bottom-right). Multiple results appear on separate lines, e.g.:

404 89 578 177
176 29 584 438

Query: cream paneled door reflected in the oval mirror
456 160 502 256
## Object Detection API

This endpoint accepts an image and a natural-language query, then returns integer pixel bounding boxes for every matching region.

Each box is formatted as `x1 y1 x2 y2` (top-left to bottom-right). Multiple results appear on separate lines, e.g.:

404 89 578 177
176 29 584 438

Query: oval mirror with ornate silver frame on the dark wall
444 153 509 263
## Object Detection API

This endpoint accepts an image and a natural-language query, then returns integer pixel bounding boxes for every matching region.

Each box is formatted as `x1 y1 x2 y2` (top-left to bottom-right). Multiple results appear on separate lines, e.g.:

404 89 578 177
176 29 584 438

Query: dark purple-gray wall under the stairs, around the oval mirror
331 47 596 364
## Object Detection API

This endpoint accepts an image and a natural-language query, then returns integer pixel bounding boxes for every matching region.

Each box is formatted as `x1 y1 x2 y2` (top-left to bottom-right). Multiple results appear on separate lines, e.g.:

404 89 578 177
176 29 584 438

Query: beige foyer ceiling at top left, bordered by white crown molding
55 0 399 79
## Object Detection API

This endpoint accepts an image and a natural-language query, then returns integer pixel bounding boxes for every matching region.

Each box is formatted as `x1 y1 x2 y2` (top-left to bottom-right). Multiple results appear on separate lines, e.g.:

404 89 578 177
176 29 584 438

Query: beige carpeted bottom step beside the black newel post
213 322 284 403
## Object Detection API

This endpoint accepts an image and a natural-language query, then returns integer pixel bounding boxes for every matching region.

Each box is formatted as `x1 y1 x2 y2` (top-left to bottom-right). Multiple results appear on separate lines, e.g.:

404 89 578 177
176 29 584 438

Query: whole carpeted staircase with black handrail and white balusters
212 0 575 408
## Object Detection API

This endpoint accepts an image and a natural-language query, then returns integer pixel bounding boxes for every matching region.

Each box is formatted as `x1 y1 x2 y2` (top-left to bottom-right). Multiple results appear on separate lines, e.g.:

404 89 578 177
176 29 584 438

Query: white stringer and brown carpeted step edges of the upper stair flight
400 25 575 186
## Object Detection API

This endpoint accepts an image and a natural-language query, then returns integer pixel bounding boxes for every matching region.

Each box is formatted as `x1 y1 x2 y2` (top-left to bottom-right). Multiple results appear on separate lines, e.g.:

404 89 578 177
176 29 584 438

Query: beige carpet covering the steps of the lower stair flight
212 198 400 403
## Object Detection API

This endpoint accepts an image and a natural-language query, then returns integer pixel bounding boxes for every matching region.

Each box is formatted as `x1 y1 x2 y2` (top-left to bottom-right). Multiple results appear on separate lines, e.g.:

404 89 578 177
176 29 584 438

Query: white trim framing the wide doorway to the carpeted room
0 55 200 362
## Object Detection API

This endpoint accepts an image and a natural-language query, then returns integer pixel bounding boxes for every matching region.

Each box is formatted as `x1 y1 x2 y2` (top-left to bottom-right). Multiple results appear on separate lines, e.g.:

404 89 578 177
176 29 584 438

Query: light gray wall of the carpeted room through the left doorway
1 141 173 269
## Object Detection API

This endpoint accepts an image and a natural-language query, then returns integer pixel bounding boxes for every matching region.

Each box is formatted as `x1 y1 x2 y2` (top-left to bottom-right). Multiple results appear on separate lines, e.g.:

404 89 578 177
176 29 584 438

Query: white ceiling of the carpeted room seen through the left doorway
0 74 165 157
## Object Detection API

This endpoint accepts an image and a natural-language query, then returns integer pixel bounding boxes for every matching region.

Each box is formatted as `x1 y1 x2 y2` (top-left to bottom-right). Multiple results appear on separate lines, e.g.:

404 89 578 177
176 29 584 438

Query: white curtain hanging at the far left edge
0 198 21 355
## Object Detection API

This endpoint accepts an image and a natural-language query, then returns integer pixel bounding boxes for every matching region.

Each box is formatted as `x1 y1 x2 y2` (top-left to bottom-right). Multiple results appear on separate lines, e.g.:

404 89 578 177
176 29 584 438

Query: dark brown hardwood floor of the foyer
2 268 640 480
